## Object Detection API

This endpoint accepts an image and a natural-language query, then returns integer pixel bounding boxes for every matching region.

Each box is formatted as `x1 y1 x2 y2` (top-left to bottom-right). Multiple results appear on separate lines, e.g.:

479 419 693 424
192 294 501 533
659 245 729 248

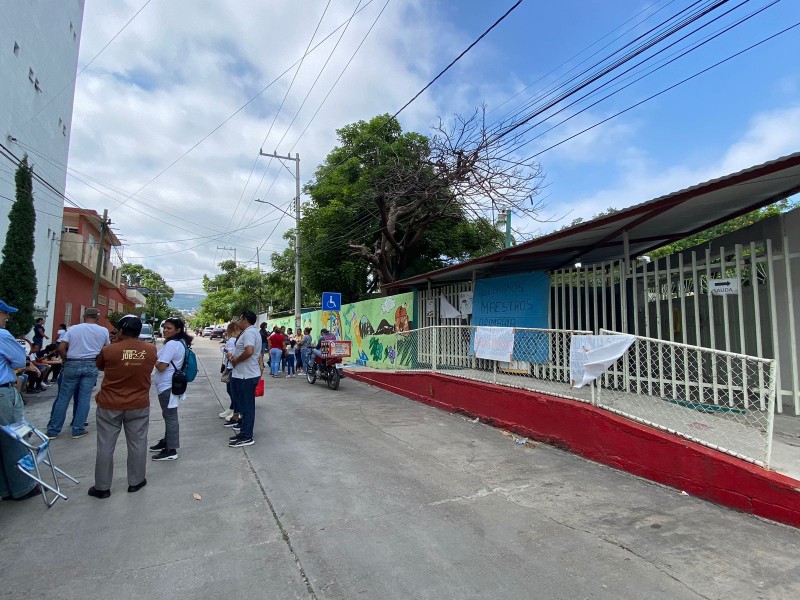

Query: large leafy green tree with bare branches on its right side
300 110 542 300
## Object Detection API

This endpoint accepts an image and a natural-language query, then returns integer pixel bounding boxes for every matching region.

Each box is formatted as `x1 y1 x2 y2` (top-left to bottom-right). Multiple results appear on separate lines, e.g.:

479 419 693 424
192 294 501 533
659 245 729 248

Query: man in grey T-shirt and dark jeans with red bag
228 310 260 448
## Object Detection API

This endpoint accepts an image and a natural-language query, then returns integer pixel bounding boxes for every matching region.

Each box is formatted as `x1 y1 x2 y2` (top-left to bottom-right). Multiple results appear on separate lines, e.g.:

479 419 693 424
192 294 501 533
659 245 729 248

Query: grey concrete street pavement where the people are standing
0 339 800 600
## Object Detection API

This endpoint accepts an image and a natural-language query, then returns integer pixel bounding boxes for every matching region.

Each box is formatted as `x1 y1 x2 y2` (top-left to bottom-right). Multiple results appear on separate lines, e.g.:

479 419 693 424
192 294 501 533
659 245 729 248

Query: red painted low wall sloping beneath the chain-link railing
348 370 800 527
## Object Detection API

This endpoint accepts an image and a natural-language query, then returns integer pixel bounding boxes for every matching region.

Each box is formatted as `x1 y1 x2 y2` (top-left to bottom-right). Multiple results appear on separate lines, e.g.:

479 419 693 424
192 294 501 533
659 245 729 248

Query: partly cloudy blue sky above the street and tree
48 0 800 292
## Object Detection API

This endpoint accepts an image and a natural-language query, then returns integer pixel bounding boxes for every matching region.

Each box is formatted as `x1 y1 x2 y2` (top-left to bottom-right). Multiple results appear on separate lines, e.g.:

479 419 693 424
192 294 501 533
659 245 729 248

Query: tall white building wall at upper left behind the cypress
0 0 85 334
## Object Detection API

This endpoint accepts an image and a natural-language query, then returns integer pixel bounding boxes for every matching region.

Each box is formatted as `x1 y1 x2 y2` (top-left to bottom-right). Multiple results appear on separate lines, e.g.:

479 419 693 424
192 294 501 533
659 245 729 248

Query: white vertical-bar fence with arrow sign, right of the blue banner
550 236 800 415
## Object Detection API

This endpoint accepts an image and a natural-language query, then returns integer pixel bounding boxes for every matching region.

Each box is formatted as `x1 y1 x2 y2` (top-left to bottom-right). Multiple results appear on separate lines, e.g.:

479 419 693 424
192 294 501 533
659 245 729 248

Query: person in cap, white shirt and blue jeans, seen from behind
47 308 111 439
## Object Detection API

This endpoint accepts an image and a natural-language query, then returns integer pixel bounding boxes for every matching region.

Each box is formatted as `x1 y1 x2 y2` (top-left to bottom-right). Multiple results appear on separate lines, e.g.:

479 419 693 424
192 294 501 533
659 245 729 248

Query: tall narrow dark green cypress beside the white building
0 155 36 337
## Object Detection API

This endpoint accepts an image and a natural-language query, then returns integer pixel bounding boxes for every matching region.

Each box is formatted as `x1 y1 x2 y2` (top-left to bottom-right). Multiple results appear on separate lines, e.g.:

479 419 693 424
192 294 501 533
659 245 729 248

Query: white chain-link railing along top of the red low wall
395 325 776 468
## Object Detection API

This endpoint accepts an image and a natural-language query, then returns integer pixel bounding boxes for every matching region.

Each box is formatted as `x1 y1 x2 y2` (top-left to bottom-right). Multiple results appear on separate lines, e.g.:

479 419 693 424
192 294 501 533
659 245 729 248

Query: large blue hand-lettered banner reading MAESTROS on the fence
470 273 550 363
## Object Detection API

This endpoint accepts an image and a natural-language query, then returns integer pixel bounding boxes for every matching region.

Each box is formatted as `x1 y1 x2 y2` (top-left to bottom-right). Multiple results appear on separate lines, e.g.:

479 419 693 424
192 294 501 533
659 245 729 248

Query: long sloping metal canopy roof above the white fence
386 152 800 291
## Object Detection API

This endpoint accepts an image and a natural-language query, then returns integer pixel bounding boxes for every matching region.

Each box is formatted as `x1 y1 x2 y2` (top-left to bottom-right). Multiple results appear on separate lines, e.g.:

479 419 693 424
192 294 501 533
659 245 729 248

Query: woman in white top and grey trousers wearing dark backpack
150 317 192 461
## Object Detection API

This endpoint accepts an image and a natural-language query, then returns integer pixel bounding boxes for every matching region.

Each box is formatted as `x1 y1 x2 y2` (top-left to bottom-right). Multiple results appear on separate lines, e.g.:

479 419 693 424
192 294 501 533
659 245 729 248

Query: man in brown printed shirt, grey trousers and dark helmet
89 315 157 499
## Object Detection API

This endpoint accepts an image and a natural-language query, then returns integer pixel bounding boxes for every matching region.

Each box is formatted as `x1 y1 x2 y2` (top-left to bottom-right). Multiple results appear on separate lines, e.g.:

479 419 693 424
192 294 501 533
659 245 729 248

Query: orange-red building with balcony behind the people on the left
53 208 144 339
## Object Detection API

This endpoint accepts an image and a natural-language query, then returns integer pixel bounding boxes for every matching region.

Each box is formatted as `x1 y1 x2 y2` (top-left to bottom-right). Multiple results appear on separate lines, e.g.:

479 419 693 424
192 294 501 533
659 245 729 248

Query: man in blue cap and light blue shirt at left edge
0 300 42 500
